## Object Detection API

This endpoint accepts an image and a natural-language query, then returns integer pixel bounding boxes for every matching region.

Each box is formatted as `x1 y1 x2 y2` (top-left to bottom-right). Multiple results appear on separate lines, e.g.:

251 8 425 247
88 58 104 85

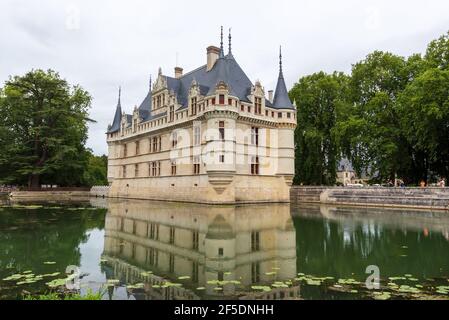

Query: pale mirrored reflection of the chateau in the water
103 200 300 299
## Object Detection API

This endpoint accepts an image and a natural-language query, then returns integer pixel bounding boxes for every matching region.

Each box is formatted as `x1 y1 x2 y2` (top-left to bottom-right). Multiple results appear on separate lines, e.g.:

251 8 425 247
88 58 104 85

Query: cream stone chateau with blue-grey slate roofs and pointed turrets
107 30 296 203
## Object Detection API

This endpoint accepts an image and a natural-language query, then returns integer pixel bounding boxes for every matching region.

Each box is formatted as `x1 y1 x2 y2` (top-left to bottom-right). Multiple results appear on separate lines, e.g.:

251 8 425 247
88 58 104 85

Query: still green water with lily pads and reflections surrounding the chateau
0 199 449 299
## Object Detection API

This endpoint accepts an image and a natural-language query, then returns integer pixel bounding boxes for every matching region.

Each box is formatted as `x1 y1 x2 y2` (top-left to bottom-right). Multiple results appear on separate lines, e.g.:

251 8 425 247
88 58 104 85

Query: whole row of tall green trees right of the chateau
290 33 449 184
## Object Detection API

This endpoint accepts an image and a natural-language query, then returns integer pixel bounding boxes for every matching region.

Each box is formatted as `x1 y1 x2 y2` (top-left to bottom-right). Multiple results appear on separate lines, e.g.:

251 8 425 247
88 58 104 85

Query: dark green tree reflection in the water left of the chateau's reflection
0 208 106 274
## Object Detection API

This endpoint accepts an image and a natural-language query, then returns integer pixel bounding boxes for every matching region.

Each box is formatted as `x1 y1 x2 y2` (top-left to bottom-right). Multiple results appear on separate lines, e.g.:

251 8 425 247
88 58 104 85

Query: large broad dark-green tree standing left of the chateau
0 70 91 187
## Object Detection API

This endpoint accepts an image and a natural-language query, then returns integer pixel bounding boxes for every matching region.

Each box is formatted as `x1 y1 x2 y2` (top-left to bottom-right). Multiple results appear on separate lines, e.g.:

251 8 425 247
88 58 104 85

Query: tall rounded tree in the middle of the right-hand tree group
337 51 417 181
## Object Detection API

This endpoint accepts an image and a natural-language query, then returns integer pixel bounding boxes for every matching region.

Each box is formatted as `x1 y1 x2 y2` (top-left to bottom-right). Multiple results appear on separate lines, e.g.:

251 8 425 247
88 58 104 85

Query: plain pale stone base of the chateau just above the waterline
109 175 291 204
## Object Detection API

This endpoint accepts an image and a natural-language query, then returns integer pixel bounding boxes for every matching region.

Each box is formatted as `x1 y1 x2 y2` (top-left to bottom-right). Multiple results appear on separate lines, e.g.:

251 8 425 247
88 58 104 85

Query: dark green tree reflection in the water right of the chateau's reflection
294 208 449 279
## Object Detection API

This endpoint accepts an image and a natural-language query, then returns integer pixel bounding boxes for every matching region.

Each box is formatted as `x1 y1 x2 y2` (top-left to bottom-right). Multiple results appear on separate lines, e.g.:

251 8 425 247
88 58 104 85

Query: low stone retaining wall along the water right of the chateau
290 186 449 210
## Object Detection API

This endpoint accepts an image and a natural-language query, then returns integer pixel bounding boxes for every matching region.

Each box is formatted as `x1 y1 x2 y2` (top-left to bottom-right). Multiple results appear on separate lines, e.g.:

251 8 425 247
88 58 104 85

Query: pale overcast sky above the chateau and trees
0 0 449 154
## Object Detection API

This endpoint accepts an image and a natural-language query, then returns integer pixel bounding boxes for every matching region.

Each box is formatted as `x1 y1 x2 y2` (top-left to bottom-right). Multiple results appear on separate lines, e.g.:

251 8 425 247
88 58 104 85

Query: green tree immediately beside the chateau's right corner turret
290 72 348 185
